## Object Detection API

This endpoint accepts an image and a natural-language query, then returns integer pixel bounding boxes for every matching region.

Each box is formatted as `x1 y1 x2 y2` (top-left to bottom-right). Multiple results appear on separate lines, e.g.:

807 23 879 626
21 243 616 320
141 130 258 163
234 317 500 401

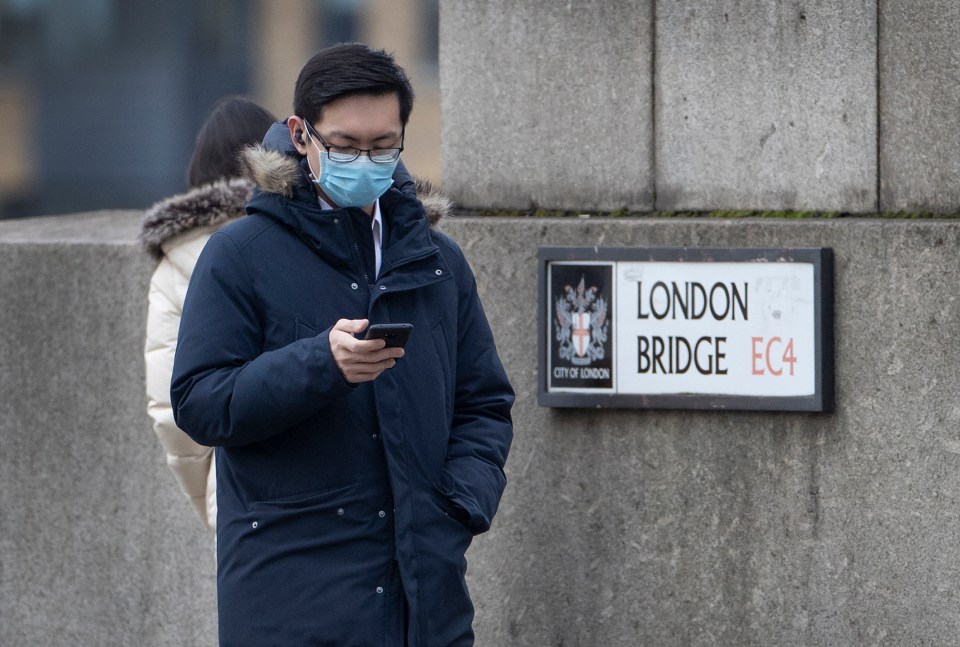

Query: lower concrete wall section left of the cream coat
0 212 216 646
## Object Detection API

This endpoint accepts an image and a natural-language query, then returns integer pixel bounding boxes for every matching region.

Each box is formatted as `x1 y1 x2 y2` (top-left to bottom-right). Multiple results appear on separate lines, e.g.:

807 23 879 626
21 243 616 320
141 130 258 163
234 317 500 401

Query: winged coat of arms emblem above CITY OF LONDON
555 277 609 366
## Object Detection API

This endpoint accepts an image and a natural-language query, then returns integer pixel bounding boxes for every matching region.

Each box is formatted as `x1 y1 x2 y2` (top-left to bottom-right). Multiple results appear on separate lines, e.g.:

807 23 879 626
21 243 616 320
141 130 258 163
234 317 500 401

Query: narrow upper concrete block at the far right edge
879 0 960 213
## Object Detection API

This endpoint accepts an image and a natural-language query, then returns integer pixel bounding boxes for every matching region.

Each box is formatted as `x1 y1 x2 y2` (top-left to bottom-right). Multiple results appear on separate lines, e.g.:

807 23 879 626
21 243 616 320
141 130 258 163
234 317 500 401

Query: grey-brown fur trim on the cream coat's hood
140 178 253 260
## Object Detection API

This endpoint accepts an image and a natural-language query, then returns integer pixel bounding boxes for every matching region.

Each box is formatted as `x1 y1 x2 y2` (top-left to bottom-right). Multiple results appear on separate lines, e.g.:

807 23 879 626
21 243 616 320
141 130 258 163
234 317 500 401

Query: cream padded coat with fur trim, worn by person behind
140 179 252 530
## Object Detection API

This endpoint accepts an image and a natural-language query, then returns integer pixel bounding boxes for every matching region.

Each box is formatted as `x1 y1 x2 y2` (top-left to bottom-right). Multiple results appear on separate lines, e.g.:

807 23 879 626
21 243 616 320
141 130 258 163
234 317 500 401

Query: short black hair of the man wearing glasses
293 43 413 126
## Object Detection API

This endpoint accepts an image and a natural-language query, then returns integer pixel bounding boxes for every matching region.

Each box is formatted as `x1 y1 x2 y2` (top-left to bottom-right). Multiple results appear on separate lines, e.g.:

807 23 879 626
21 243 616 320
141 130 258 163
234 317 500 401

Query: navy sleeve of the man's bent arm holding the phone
171 231 353 447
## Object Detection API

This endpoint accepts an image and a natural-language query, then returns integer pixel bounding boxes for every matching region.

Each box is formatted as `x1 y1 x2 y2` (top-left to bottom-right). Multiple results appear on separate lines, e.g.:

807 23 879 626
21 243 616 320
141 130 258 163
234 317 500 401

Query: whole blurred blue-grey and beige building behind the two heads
0 0 440 218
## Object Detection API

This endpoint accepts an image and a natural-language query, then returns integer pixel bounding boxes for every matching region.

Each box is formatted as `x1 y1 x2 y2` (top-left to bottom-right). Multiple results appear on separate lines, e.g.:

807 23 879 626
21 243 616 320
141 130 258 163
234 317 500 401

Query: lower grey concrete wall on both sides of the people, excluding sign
0 212 960 647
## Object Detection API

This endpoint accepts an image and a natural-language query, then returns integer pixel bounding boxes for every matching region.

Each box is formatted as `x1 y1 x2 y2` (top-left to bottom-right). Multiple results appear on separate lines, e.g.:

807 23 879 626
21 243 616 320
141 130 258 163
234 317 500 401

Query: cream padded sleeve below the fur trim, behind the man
144 259 214 528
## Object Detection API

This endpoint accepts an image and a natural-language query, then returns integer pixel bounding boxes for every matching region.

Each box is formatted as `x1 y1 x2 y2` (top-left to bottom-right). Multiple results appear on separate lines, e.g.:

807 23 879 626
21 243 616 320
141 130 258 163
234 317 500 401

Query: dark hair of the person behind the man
187 96 277 188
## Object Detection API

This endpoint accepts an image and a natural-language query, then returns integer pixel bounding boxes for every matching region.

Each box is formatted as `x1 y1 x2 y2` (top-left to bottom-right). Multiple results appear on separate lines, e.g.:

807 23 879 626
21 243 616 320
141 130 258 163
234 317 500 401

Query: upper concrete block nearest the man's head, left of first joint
440 0 654 210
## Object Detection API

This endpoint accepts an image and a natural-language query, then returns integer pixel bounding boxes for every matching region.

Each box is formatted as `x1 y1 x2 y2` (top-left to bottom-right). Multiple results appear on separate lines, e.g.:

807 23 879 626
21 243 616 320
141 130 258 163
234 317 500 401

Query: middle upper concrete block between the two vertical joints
655 0 877 211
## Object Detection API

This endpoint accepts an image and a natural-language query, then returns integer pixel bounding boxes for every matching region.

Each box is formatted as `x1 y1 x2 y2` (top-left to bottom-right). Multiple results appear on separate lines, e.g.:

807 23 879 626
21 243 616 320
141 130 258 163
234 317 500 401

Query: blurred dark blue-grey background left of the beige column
0 0 251 217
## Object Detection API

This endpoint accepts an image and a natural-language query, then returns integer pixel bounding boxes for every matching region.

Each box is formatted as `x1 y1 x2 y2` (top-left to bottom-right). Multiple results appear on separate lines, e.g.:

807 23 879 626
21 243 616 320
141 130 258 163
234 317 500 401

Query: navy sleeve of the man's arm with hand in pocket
442 246 514 534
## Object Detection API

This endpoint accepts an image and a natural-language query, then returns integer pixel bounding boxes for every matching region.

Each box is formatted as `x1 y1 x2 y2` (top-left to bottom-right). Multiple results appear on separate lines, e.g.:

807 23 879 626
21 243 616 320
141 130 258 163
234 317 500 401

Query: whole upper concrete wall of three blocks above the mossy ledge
440 0 960 213
